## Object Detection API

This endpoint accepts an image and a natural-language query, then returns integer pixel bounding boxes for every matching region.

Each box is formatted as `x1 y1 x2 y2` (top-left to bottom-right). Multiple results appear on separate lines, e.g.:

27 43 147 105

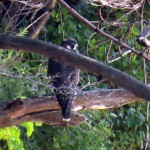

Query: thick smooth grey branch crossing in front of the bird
0 34 150 101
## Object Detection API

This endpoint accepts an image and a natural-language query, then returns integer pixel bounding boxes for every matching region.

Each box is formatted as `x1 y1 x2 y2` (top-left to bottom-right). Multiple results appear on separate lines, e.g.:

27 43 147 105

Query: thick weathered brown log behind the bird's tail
0 89 142 128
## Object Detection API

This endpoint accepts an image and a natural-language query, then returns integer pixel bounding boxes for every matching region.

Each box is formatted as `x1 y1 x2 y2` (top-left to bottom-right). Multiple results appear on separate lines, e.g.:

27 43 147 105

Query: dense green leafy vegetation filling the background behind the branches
0 1 150 150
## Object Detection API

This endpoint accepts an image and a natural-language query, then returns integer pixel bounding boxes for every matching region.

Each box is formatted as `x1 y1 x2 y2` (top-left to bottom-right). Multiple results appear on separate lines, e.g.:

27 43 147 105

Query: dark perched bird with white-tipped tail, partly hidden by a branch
48 38 80 122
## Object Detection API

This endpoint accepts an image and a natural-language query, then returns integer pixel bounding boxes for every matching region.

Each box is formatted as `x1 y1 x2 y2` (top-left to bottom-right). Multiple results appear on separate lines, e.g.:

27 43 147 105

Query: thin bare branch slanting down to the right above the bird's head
58 0 150 61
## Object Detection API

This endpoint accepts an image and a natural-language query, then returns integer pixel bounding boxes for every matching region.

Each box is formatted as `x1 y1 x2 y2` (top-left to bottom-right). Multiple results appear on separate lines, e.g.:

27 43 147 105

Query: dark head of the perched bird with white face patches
61 38 78 53
